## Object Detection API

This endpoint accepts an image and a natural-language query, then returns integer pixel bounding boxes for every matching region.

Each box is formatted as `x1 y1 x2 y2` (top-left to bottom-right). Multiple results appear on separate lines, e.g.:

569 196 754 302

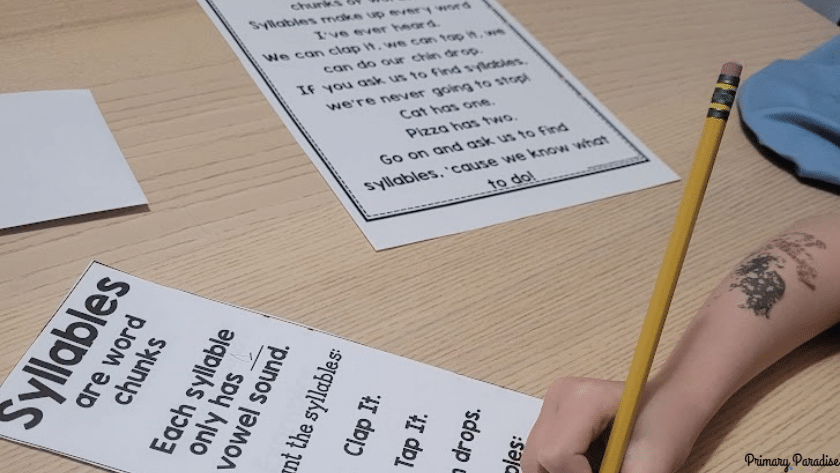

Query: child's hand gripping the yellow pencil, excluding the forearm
522 378 696 473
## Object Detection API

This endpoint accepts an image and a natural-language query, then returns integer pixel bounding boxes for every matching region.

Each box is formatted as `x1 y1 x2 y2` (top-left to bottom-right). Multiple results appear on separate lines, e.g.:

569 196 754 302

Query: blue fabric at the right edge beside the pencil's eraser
737 36 840 186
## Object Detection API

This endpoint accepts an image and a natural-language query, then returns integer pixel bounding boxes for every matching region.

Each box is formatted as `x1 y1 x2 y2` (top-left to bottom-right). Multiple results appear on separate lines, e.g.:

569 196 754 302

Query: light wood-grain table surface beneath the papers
0 0 840 472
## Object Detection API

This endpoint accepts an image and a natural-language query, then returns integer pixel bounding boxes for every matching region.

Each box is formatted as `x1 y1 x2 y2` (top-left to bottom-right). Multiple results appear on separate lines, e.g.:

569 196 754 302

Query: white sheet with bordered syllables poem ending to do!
198 0 677 249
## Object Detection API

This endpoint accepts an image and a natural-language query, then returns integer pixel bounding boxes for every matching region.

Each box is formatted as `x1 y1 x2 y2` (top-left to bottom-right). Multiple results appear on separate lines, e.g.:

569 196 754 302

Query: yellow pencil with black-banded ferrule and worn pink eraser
600 62 742 473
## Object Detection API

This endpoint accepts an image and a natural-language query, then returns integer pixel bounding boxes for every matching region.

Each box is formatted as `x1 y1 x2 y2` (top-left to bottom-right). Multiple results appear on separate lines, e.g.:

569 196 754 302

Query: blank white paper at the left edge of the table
0 90 148 228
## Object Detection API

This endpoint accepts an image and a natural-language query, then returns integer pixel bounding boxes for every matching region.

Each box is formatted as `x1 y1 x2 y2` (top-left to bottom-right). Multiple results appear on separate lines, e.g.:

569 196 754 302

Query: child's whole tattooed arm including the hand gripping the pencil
522 215 840 473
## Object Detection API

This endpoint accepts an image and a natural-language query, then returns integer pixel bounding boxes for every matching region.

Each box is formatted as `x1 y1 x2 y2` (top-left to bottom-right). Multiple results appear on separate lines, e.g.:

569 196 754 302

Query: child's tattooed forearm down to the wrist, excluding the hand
648 216 840 434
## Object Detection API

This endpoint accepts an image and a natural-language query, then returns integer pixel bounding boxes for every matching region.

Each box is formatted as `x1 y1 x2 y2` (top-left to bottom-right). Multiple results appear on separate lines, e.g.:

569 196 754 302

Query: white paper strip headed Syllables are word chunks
0 263 541 473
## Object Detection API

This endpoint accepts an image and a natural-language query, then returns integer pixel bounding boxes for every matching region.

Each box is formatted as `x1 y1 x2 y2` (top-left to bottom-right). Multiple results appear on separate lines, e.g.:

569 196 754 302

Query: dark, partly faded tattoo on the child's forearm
729 232 825 319
